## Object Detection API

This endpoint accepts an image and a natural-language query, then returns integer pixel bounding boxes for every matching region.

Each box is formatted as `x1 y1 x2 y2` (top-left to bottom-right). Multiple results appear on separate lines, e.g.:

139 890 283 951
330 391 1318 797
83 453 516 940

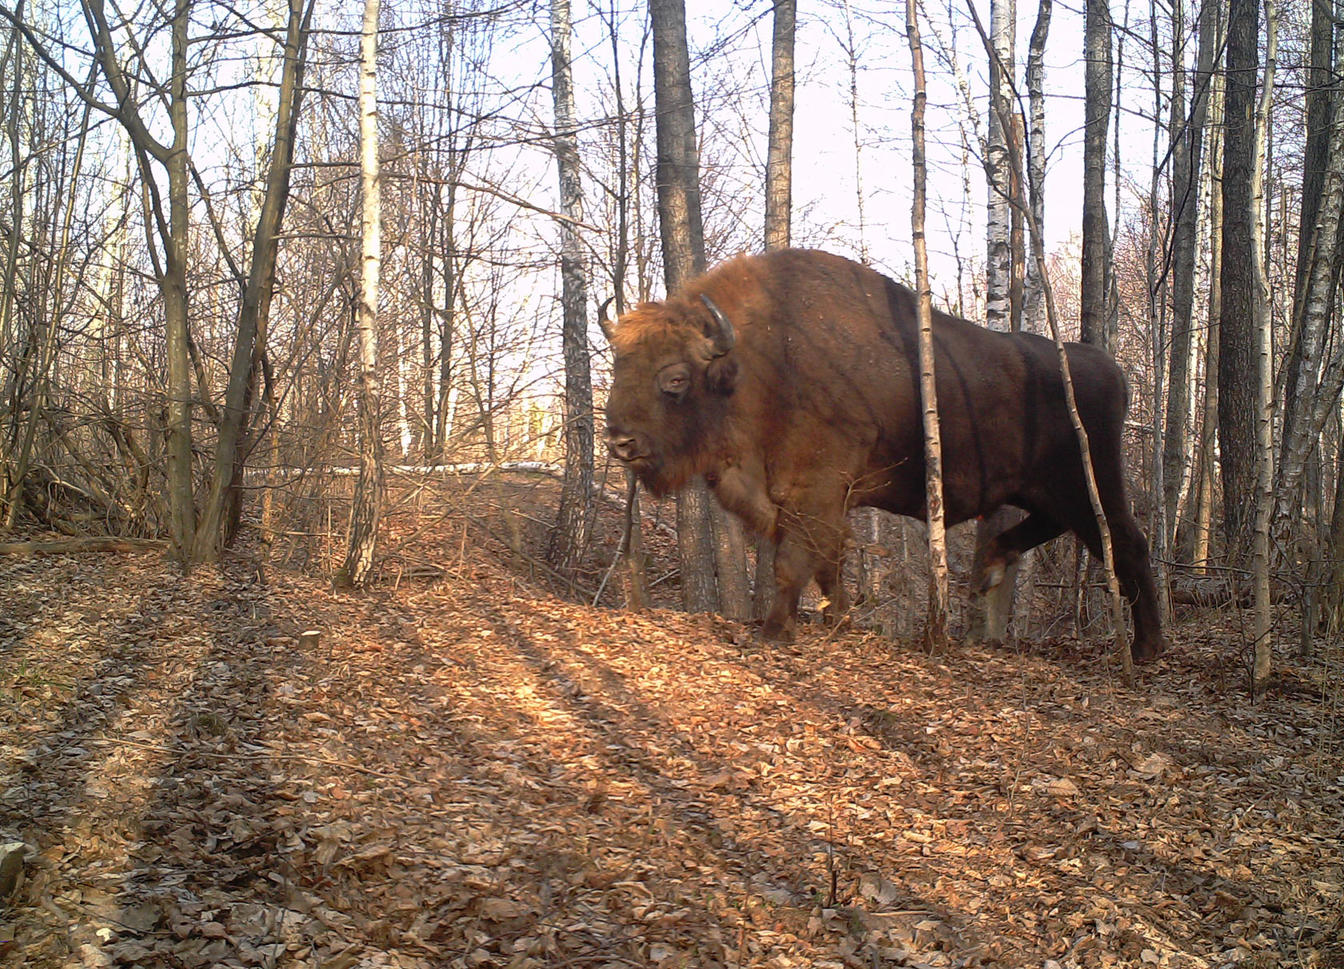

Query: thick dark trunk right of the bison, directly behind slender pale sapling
1218 0 1262 559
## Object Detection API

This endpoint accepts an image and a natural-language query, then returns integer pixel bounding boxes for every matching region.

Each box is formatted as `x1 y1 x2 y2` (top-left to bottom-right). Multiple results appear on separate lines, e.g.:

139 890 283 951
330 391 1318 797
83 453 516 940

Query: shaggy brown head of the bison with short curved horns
603 296 738 495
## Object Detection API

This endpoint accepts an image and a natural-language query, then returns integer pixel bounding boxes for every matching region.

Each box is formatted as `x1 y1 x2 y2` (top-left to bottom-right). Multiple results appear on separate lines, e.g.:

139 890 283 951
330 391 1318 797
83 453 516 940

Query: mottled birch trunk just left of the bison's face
548 0 593 577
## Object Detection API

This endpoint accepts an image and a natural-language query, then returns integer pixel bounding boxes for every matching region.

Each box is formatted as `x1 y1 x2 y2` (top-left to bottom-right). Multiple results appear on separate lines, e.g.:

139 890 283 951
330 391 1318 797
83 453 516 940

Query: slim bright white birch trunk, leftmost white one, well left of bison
336 0 384 586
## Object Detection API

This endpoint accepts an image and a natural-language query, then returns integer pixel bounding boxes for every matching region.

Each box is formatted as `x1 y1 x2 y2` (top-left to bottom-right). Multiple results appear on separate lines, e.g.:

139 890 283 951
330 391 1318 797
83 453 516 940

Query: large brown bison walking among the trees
606 250 1165 660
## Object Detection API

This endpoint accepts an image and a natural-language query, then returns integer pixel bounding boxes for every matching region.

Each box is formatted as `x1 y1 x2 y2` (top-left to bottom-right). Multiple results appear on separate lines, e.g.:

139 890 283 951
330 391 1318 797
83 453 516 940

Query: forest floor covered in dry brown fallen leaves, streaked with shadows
0 473 1344 969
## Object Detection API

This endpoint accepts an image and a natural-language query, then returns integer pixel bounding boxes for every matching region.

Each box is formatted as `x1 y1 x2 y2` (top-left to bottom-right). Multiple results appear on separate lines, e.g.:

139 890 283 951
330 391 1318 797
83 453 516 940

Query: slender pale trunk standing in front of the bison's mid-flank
906 0 946 652
